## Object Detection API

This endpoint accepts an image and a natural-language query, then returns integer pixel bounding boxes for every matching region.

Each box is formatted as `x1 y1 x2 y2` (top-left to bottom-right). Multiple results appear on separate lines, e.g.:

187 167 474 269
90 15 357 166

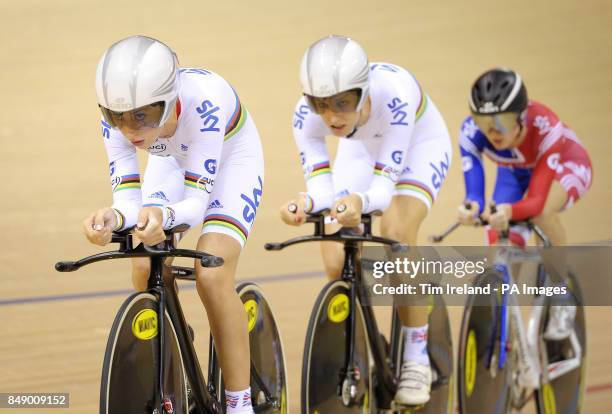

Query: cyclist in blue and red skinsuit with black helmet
459 69 593 340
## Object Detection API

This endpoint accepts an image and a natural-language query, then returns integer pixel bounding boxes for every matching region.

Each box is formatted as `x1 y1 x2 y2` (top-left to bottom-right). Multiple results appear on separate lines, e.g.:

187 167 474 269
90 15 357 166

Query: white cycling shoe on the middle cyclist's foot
395 361 431 405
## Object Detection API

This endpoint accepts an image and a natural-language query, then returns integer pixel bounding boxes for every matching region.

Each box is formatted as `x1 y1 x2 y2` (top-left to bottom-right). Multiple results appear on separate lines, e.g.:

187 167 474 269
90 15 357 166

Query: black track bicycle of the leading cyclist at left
55 225 287 414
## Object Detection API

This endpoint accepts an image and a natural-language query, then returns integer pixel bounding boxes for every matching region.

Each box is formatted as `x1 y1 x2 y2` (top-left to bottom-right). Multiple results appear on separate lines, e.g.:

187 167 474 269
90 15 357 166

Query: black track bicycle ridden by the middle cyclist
265 213 453 414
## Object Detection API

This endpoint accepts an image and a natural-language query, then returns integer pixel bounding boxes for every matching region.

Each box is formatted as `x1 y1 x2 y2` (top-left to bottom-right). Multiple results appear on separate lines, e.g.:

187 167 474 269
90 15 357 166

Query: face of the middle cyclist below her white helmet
306 90 360 137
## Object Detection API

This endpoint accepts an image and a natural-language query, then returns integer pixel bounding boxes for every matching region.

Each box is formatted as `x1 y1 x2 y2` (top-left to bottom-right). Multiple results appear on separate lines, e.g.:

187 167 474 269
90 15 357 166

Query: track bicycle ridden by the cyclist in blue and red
431 210 587 414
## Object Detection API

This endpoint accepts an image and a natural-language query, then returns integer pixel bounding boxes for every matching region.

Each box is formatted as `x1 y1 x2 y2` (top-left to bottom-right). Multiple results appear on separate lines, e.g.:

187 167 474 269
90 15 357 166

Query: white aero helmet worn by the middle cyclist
300 35 370 111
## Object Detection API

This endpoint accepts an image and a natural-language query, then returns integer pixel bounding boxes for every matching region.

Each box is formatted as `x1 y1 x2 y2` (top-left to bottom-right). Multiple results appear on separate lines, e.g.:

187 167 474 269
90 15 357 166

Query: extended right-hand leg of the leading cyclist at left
196 117 264 413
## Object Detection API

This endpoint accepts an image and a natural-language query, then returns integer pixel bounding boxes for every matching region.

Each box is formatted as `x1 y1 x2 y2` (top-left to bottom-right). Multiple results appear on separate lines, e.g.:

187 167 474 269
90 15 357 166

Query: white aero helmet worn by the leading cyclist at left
96 36 178 127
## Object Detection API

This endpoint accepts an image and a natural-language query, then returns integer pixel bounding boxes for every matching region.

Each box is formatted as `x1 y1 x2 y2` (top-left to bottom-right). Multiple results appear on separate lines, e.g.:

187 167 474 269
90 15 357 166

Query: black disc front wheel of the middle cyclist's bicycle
302 280 375 414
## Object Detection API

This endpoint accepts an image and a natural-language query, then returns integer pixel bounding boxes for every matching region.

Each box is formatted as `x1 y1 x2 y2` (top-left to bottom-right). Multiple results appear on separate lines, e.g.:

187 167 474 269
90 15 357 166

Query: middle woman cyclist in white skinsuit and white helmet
281 36 452 405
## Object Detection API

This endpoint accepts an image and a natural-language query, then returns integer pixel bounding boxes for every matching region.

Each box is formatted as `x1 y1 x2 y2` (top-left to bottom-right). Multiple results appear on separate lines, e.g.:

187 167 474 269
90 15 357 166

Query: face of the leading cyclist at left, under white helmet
101 104 164 149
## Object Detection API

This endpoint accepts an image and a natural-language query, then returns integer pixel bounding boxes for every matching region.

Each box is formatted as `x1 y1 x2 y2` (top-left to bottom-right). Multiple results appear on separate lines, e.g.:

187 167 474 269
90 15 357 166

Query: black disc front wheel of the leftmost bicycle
100 292 187 414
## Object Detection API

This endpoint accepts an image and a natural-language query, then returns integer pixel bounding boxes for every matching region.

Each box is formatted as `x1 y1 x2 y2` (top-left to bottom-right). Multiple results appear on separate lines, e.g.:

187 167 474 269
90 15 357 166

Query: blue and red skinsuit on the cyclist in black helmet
459 100 593 245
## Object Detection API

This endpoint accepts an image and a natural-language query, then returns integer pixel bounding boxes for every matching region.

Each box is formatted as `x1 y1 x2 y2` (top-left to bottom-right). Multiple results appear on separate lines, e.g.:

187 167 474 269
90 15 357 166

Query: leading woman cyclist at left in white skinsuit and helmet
83 36 264 414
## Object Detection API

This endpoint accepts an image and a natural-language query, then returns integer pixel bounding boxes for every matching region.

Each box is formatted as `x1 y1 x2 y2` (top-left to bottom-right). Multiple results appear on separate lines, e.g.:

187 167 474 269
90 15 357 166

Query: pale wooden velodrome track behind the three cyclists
0 0 612 413
